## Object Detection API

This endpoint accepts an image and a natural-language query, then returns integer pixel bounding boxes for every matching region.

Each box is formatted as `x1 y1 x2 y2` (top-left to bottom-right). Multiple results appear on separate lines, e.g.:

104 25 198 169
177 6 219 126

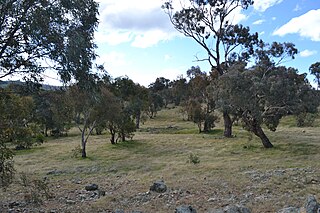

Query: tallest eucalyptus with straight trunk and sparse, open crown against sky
162 0 258 137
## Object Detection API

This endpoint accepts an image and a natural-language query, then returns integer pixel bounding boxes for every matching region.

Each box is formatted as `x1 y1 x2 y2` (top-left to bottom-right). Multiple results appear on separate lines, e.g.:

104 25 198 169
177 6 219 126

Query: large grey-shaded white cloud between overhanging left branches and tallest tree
95 0 178 48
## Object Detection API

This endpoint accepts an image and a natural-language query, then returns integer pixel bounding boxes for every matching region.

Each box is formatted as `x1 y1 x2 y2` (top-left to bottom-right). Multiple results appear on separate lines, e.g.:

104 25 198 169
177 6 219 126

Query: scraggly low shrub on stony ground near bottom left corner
19 173 52 205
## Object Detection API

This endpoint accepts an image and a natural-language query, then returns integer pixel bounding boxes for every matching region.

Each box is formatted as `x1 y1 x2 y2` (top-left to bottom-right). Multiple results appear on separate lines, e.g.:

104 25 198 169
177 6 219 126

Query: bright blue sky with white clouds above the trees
46 0 320 86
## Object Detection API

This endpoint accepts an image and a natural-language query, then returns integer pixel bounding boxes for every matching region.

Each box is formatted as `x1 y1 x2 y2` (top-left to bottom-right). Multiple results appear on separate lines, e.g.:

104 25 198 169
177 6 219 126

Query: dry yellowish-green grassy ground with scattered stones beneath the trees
0 108 320 212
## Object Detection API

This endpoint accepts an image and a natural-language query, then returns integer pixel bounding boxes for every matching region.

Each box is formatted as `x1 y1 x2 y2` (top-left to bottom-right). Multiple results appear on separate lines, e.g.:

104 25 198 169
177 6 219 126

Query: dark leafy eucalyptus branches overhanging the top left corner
0 0 98 82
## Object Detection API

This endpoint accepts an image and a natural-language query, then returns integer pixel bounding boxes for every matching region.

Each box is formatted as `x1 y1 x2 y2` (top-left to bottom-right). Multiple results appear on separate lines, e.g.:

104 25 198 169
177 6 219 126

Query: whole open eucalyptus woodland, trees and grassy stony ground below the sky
0 0 320 213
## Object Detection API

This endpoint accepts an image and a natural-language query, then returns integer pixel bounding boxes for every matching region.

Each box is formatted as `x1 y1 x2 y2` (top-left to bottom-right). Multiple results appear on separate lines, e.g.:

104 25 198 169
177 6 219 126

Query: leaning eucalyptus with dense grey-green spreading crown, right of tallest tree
212 42 319 148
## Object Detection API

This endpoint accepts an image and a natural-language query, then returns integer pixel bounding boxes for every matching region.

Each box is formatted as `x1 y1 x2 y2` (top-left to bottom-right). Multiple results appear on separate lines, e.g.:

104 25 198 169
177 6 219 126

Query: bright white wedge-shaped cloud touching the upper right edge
273 9 320 41
